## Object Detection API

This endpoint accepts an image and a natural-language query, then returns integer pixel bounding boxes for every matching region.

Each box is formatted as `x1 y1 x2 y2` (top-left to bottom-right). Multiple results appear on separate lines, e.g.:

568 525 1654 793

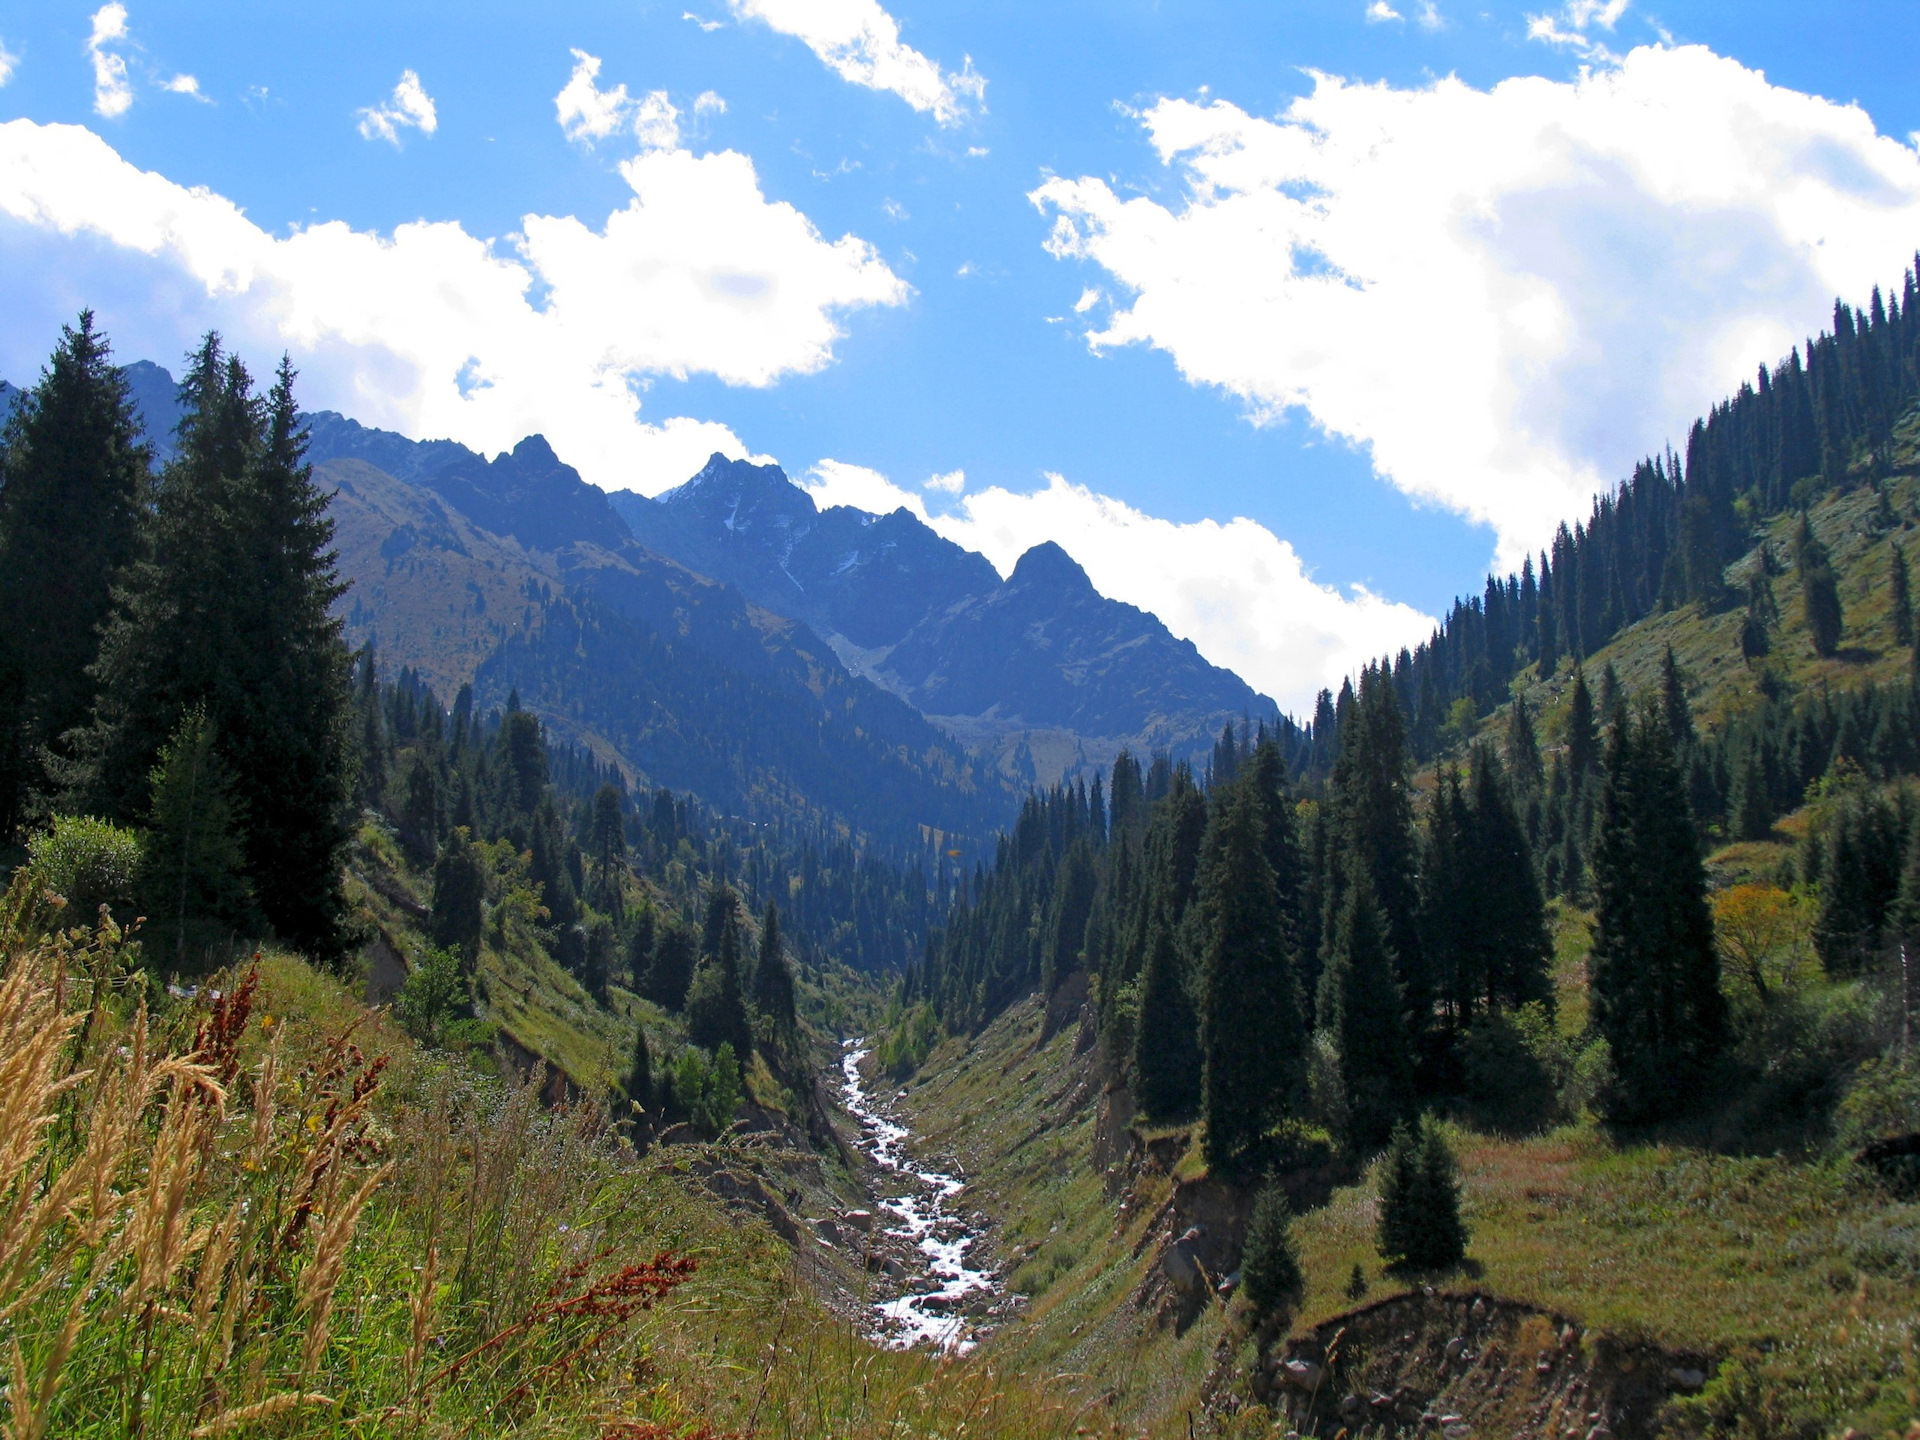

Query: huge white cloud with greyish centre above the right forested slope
1031 48 1920 563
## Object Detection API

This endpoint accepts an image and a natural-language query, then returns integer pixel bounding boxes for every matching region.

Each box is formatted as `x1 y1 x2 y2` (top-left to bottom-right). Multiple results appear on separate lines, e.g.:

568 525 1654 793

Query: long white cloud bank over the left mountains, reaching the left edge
0 119 906 493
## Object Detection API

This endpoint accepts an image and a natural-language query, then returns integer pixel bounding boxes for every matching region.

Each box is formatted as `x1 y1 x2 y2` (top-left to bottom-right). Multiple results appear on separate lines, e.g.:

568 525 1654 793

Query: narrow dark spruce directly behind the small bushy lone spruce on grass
1315 864 1413 1150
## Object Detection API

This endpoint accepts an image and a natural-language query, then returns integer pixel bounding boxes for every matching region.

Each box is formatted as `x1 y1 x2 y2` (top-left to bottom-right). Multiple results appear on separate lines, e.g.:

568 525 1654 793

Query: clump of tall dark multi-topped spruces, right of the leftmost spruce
73 334 351 956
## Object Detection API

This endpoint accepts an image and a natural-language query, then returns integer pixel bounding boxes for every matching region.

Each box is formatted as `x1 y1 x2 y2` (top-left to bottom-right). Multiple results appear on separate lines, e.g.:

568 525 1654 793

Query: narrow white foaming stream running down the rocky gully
841 1041 996 1356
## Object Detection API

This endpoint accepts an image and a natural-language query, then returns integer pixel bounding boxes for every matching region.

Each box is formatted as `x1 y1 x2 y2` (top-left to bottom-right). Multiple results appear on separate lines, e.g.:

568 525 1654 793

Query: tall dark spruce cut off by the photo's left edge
0 311 150 839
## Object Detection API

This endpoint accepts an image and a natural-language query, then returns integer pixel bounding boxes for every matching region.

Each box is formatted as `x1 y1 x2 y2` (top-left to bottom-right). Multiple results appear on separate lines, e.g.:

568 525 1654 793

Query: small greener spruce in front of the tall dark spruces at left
138 708 259 970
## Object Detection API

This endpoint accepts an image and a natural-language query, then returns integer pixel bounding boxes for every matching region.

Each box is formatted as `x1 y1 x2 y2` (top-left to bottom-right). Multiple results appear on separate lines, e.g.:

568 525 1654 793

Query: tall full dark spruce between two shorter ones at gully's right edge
1194 768 1308 1173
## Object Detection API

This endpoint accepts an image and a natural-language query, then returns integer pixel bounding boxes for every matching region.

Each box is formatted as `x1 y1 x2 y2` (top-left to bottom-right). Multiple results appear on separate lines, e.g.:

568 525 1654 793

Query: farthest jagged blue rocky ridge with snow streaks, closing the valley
612 455 1277 780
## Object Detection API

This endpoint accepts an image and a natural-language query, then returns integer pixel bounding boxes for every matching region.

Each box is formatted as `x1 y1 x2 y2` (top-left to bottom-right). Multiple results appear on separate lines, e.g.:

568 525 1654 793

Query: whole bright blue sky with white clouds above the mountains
0 0 1920 712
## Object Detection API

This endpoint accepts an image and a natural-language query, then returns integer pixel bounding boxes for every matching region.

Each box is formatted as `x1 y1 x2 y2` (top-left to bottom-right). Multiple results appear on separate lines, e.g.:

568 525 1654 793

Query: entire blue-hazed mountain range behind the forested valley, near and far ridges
11 361 1279 843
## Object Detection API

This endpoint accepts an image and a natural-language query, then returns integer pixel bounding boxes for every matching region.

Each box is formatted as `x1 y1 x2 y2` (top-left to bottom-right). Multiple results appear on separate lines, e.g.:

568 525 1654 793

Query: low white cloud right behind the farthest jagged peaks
803 461 1434 712
